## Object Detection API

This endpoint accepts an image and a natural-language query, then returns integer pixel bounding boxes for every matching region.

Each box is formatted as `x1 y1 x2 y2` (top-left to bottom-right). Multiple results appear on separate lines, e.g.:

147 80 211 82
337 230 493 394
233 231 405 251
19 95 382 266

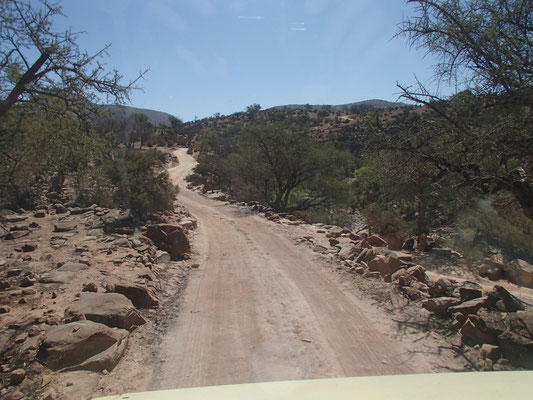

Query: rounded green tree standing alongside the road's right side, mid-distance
225 123 352 211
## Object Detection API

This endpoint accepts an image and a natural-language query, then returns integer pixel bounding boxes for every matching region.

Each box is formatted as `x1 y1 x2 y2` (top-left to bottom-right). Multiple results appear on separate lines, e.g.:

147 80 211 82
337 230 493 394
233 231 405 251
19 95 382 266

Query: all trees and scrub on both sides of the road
0 0 533 253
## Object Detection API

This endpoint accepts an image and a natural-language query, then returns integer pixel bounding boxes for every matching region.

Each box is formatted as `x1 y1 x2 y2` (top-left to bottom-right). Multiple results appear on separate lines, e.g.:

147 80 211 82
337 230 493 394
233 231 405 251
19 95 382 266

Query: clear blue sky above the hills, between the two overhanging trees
56 0 442 121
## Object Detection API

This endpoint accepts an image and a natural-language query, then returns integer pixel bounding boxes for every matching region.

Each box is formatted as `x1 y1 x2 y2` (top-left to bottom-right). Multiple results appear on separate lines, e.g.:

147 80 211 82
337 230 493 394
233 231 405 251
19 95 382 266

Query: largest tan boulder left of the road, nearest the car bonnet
37 321 129 371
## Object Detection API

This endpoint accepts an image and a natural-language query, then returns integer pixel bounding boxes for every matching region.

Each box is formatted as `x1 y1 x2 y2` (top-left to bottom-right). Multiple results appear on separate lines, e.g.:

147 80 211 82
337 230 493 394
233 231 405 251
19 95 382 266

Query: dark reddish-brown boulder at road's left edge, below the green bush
144 224 191 260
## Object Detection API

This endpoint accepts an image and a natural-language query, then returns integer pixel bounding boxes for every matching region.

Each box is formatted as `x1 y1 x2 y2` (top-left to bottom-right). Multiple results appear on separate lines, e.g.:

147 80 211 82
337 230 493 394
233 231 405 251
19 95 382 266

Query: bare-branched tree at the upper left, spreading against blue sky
0 0 146 126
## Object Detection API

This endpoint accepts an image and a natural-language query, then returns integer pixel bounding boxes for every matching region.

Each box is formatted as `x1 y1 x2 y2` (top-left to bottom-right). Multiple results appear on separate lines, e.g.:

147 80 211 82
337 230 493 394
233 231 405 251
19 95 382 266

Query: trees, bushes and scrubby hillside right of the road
186 0 533 259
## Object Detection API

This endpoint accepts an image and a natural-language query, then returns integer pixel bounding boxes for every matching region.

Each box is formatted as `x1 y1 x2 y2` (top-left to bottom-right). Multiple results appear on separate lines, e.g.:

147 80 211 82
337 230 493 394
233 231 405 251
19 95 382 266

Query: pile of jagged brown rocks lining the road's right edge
303 227 533 370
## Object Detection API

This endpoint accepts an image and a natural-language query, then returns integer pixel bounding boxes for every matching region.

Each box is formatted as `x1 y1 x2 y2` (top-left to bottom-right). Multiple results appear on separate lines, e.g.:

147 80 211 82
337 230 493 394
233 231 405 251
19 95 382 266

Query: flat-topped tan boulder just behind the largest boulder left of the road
65 292 146 329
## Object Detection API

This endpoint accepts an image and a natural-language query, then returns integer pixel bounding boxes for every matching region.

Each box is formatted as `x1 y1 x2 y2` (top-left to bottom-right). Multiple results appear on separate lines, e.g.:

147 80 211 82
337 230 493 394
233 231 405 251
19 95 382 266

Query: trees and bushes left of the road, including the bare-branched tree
0 0 183 219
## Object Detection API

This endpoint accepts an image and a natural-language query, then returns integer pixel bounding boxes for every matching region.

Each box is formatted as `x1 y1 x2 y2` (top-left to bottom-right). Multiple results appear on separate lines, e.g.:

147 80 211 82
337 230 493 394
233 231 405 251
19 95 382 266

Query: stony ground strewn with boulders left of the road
0 203 196 400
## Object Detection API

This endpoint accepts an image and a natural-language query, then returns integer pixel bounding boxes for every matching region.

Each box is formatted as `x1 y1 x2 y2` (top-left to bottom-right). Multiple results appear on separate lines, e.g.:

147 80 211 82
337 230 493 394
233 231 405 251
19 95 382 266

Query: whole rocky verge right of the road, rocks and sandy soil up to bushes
191 187 533 371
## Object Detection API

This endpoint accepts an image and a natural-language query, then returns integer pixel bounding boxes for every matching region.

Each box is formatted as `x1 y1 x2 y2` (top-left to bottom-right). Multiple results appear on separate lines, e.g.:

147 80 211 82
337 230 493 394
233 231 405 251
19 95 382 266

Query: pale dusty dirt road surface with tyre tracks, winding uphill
152 149 430 389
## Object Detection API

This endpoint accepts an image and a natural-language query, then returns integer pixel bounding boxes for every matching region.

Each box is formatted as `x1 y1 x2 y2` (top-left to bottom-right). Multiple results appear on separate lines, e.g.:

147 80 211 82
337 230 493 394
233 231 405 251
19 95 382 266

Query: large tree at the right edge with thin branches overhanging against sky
386 0 533 220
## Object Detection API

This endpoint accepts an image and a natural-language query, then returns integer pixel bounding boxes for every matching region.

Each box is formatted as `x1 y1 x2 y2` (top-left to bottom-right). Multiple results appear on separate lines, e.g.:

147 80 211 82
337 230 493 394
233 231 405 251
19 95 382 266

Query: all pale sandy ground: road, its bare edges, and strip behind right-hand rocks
93 149 533 395
